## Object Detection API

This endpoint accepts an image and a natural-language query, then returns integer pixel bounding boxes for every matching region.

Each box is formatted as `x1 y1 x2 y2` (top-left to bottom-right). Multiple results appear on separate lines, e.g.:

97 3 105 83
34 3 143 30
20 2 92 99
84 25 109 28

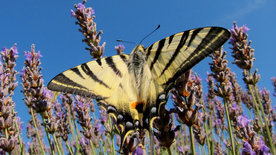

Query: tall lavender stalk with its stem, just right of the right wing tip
230 23 275 154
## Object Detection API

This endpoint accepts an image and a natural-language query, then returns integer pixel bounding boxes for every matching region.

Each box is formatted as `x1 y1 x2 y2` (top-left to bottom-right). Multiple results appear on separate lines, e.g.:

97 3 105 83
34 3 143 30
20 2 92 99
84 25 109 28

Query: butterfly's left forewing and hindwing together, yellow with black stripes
47 55 138 127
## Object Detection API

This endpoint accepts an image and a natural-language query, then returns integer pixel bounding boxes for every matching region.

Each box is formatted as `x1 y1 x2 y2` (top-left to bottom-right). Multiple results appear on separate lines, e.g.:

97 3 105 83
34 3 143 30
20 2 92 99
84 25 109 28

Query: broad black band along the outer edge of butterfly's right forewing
163 27 230 89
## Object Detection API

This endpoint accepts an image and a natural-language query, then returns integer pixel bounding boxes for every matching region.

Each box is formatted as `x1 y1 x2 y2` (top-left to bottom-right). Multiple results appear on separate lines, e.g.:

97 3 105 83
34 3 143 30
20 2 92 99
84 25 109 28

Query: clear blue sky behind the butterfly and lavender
0 0 276 140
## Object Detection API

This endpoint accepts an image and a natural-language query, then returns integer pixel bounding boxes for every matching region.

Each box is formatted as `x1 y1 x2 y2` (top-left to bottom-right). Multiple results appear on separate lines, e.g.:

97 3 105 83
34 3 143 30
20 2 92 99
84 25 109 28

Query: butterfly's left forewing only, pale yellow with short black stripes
48 55 128 99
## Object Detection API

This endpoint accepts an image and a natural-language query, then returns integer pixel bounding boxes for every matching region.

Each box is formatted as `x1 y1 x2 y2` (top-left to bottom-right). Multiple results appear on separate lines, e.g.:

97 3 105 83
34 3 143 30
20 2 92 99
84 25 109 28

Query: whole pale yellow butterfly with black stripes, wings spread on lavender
47 27 230 144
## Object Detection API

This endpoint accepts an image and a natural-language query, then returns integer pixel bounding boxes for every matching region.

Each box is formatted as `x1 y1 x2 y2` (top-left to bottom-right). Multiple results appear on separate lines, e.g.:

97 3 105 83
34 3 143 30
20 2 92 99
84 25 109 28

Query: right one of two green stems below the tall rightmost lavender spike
254 85 275 154
